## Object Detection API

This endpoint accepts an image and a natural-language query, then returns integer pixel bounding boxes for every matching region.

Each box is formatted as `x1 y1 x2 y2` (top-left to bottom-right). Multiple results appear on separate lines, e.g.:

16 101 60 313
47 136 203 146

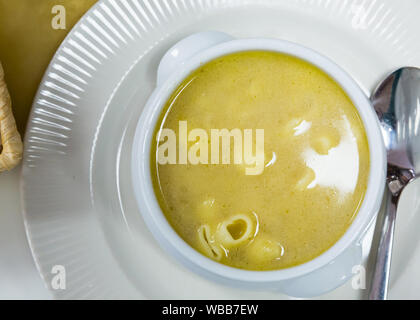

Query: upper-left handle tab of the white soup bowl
157 31 234 86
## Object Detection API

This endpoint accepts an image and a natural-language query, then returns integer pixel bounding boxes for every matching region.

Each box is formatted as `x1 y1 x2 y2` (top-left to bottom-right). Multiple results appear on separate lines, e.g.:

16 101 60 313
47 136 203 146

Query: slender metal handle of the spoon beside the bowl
369 190 398 300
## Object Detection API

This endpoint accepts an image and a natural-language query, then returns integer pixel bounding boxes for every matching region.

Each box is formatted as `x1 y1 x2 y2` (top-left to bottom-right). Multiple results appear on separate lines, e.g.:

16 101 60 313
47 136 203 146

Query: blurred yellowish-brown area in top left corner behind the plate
0 0 96 136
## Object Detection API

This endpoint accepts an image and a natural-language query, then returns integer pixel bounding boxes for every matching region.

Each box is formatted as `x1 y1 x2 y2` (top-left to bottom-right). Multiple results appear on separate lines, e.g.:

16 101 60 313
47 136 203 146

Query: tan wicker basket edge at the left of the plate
0 62 23 172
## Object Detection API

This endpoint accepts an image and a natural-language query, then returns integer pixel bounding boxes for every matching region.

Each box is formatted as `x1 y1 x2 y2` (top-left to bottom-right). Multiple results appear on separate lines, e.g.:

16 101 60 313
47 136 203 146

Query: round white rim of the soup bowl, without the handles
131 38 386 283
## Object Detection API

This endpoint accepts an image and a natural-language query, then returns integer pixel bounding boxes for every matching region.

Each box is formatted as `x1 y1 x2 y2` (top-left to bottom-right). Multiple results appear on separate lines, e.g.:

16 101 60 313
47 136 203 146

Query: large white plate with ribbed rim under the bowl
22 0 420 299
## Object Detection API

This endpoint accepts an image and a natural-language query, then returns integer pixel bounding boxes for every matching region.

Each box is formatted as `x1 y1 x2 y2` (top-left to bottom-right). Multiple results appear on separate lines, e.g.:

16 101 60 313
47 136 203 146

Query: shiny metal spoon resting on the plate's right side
369 67 420 300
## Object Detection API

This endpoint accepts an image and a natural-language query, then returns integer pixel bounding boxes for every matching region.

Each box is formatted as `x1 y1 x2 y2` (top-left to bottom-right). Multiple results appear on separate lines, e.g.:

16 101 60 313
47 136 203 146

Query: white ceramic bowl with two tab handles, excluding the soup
132 32 386 297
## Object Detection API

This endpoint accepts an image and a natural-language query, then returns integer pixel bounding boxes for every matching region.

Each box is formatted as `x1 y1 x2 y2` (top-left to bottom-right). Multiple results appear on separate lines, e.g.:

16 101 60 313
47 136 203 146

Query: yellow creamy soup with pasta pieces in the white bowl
151 51 369 270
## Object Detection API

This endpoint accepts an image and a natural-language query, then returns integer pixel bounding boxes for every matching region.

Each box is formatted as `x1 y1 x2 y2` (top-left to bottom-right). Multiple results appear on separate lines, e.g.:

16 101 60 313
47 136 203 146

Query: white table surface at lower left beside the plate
0 167 52 299
